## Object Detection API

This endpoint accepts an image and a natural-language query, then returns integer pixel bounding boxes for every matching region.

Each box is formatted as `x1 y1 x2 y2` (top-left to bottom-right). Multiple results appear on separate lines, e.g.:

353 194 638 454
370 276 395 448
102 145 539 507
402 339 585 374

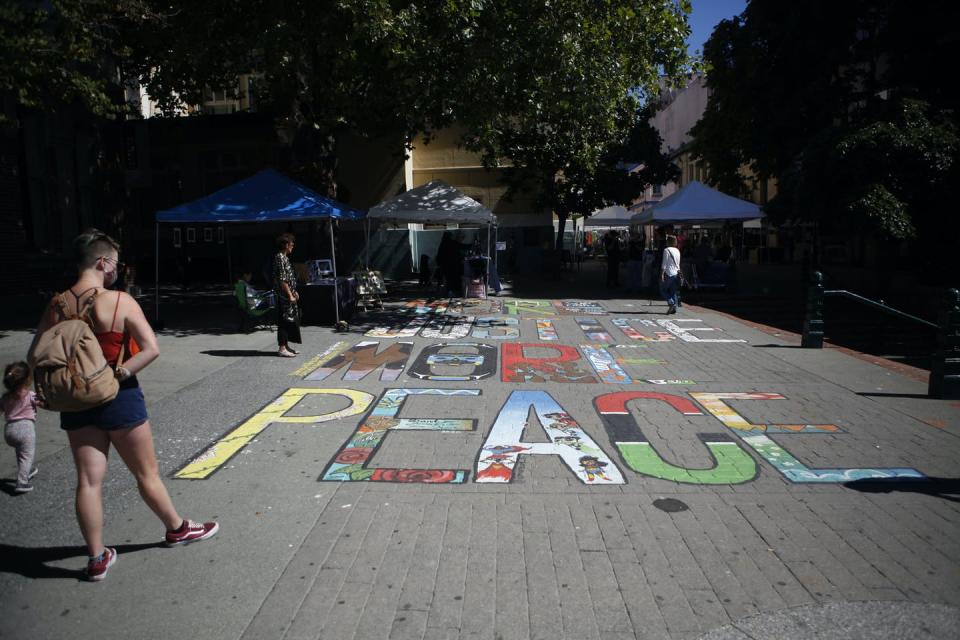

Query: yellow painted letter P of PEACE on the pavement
173 388 373 480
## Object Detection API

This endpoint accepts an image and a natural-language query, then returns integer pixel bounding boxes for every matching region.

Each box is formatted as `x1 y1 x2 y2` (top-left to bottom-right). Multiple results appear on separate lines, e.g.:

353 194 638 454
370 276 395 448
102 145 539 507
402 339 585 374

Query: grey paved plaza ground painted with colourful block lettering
0 292 960 639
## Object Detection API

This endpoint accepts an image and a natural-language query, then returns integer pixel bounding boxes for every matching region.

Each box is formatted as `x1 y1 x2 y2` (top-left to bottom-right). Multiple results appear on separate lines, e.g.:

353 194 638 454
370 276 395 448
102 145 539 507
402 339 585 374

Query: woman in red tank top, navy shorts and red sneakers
27 229 219 581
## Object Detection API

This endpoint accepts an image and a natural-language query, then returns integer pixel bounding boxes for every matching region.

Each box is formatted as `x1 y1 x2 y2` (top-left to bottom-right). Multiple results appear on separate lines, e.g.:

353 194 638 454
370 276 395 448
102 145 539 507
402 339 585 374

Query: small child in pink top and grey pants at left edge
2 361 37 493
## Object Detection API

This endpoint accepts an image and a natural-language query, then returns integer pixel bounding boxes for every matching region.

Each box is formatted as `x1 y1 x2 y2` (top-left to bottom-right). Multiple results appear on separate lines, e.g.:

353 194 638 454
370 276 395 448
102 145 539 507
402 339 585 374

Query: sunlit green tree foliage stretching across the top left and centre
0 0 690 215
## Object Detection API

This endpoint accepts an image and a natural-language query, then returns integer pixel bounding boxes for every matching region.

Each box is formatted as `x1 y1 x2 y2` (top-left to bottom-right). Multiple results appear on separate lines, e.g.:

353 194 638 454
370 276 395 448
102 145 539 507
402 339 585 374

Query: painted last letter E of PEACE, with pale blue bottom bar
690 392 926 483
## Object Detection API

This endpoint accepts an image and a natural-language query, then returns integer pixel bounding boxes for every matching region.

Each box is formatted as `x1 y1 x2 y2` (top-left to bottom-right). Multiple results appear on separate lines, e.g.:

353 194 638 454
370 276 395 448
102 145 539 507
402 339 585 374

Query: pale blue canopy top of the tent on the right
631 180 764 225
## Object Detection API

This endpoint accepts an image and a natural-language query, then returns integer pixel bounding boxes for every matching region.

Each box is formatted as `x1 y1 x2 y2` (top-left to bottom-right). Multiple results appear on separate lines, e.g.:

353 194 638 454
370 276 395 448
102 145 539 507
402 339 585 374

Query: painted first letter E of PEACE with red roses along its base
319 389 480 484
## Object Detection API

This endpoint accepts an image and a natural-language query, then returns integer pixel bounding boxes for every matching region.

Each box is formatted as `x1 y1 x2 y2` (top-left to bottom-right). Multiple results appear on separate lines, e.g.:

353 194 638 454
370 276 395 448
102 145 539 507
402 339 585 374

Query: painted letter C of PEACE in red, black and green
593 391 757 484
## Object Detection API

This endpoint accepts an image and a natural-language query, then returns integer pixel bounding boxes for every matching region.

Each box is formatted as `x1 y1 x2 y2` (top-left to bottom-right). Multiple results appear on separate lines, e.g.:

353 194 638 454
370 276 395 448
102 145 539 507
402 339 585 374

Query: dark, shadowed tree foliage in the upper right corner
691 0 960 238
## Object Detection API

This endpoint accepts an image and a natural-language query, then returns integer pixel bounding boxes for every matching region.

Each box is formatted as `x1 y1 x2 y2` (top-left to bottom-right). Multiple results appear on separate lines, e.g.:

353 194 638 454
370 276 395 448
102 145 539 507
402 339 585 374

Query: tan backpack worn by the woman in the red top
30 292 123 412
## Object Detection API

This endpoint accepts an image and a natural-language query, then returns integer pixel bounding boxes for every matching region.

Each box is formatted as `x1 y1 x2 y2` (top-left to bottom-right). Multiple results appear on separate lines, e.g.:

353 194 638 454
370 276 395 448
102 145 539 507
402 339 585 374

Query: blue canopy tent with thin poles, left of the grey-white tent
154 169 366 324
